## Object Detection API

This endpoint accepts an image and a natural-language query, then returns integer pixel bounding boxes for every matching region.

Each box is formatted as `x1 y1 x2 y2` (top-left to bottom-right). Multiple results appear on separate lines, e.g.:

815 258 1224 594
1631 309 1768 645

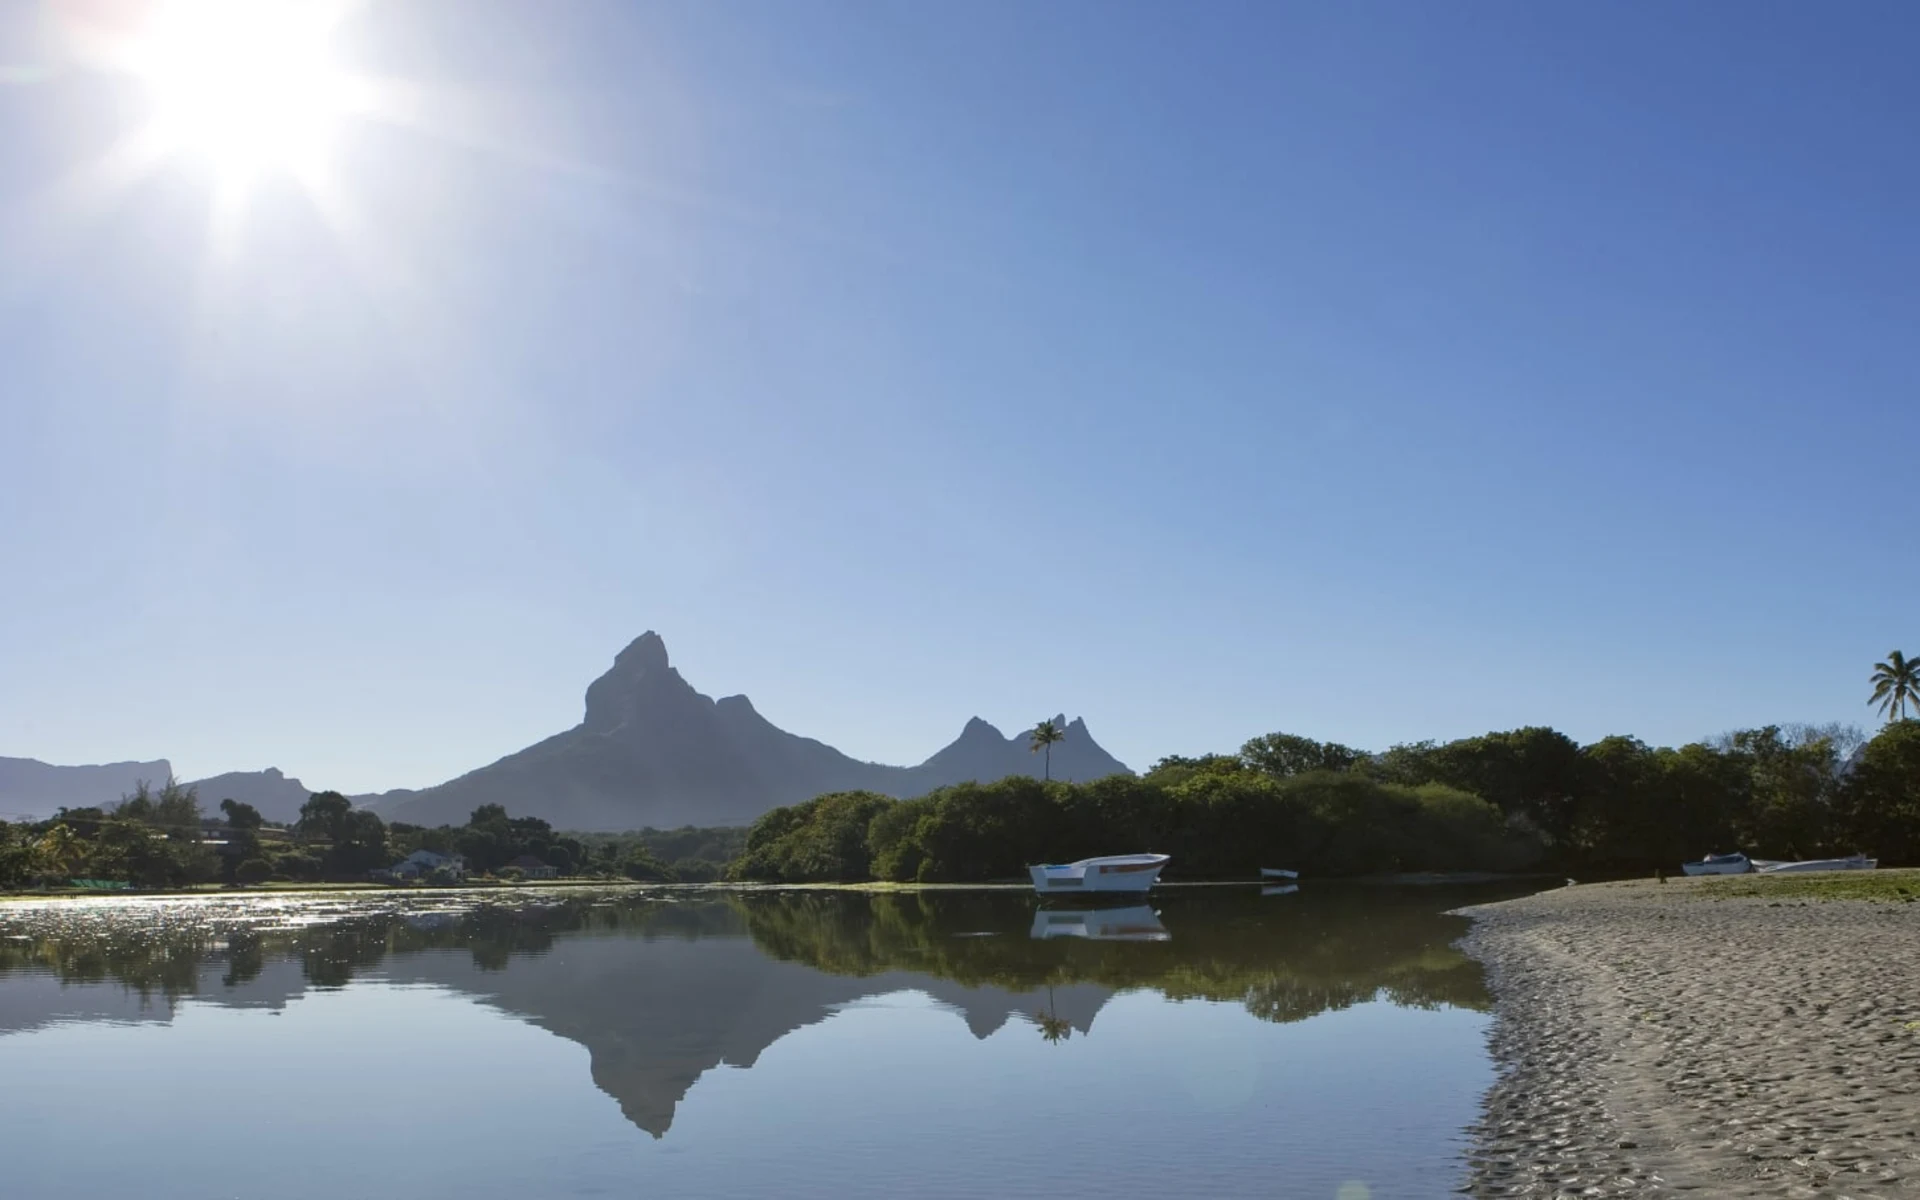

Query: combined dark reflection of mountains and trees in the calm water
0 887 1511 1137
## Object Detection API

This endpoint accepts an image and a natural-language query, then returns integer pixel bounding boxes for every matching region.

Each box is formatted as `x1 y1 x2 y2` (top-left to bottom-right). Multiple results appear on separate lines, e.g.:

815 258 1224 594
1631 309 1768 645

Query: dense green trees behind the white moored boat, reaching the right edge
733 720 1920 883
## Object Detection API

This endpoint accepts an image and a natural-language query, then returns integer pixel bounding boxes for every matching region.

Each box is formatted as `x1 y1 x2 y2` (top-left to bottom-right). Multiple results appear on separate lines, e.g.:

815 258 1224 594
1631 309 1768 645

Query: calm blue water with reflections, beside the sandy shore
0 885 1513 1200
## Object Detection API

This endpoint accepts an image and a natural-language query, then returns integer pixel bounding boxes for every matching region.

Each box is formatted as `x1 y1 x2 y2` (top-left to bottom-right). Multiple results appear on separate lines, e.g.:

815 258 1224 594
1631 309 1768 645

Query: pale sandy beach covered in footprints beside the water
1463 872 1920 1198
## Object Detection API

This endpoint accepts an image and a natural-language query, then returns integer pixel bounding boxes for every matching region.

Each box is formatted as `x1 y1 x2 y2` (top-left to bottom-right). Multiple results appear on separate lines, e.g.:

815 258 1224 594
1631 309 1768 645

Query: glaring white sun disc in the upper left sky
125 0 357 177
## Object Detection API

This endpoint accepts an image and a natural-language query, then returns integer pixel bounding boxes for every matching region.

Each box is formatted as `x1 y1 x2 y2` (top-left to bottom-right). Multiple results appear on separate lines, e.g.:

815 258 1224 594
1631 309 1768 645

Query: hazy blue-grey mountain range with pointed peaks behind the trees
0 632 1127 831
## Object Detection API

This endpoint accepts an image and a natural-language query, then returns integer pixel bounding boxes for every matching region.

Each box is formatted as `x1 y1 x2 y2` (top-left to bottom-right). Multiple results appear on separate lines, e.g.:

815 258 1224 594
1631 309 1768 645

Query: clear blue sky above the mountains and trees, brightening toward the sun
0 0 1920 791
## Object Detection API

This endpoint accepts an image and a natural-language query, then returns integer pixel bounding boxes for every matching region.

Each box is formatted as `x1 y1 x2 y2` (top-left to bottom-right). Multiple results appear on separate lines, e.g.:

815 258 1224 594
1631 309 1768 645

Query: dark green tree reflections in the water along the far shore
0 887 1520 1041
